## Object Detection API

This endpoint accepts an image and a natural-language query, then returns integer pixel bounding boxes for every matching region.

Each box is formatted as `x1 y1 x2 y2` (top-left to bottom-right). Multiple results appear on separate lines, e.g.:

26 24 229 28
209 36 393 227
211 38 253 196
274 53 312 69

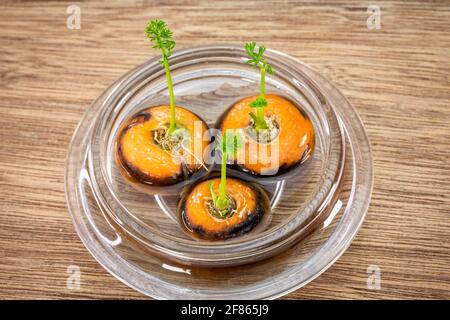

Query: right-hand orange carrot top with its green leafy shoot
216 42 314 176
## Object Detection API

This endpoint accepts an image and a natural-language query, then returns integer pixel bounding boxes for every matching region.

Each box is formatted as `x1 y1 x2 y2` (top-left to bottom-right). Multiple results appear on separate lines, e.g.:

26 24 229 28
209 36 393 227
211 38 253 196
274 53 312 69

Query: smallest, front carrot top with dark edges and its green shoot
178 134 270 240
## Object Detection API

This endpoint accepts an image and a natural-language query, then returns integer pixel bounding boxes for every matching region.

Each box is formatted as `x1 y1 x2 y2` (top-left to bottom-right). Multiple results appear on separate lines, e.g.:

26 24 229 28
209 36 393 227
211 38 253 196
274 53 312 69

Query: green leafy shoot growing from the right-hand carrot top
245 41 275 131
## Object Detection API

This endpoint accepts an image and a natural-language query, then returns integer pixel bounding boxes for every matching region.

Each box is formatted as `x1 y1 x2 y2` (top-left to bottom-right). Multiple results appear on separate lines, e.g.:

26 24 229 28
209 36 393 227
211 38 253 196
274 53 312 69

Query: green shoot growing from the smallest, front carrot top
209 132 243 211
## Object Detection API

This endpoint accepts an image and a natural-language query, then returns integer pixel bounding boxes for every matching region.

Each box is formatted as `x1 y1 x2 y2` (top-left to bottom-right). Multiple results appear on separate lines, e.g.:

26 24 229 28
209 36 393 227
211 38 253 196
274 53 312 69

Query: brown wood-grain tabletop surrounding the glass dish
0 0 450 299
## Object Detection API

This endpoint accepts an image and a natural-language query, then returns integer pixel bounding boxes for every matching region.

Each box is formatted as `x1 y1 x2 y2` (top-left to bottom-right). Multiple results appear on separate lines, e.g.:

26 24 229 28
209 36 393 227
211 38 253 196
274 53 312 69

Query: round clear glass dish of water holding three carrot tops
66 45 373 299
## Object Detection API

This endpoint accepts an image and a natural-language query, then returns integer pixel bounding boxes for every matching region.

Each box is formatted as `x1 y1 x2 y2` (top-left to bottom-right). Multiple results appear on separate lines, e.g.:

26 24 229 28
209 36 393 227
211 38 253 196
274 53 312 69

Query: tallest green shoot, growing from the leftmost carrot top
145 19 176 134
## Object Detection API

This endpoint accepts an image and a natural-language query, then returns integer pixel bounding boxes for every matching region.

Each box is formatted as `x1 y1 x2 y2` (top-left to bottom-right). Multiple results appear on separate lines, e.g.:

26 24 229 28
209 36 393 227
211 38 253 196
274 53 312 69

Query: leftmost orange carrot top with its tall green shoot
116 20 209 190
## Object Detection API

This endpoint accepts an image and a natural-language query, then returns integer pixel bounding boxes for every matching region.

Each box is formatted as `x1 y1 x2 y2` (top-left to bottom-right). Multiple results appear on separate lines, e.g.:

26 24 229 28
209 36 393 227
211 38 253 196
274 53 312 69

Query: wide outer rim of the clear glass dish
65 45 373 299
